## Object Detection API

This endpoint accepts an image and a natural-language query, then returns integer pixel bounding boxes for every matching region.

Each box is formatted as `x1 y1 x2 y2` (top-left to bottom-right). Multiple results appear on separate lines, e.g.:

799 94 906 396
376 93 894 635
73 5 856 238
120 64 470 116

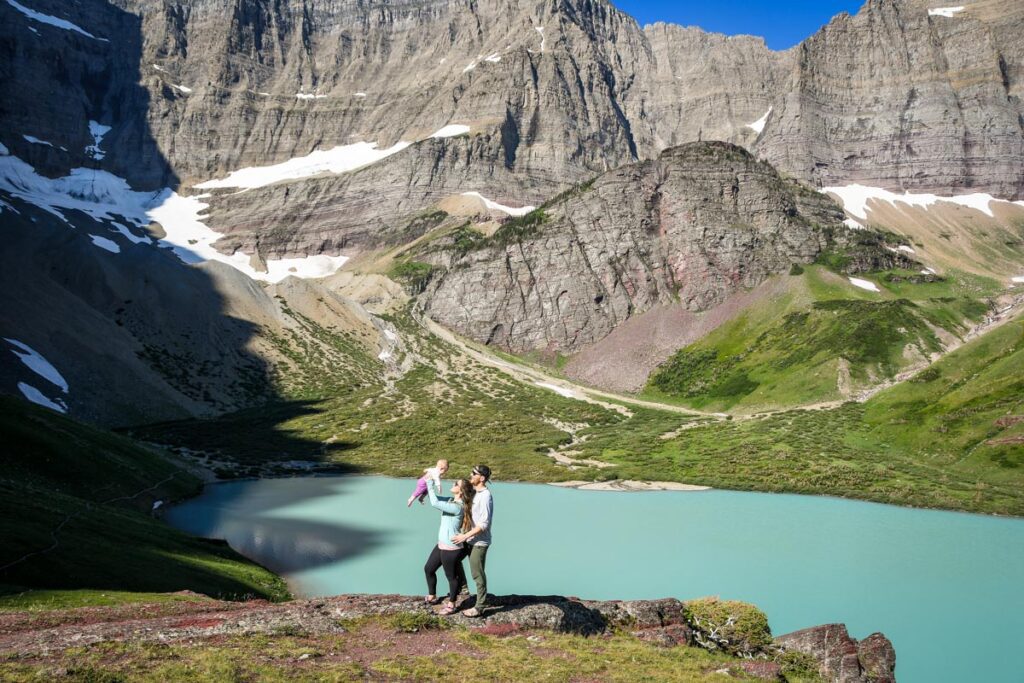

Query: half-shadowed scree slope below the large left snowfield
0 189 385 426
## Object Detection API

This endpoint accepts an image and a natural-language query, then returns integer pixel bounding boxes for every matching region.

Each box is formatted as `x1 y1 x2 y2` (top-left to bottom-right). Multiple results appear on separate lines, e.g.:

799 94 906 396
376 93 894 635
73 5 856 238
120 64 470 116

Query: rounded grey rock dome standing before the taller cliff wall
419 142 843 351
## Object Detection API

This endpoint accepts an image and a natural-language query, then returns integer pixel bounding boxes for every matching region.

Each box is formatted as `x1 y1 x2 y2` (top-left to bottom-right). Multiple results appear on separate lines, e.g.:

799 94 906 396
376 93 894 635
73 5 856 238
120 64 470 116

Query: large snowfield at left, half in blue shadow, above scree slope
0 147 348 283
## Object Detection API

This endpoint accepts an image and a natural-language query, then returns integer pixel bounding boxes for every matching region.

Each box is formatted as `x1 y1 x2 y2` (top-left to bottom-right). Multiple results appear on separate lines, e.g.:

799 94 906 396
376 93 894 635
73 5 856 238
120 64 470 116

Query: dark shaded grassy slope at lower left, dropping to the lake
0 397 288 606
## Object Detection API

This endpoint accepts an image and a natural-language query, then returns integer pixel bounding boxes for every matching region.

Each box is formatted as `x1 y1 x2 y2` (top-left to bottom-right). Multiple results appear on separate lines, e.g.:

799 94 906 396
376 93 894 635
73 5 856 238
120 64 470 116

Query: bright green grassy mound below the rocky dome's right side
645 266 995 413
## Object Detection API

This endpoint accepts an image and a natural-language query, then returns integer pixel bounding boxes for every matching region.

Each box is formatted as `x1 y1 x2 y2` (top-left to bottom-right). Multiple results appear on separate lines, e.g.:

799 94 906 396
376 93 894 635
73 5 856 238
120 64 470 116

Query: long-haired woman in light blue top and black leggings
423 479 476 614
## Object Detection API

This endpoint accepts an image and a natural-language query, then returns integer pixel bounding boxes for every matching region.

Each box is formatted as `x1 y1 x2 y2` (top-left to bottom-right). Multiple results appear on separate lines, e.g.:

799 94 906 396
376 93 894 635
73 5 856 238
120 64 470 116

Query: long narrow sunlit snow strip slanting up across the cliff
196 141 412 189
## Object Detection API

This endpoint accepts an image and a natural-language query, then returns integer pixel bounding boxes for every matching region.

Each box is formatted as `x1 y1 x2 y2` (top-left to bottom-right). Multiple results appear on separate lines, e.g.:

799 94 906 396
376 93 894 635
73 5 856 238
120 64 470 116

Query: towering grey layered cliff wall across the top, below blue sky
0 0 1024 264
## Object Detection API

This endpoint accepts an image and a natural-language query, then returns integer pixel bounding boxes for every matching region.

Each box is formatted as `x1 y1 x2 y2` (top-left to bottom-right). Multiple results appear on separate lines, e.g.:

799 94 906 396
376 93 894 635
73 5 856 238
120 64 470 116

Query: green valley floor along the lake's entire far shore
139 305 1024 514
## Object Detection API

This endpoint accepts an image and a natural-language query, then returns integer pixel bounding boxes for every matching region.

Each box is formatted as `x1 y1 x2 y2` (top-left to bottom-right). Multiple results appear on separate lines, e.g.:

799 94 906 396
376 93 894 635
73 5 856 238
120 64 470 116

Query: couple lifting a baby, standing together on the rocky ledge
409 460 495 616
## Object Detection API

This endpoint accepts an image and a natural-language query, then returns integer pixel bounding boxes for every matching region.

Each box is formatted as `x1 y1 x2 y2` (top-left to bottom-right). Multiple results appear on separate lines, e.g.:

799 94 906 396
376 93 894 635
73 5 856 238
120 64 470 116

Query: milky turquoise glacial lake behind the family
167 476 1024 683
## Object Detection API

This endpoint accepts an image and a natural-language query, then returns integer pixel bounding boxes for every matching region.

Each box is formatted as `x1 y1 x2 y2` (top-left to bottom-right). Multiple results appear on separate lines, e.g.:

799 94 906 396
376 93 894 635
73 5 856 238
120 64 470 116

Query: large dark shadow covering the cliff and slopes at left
0 0 373 597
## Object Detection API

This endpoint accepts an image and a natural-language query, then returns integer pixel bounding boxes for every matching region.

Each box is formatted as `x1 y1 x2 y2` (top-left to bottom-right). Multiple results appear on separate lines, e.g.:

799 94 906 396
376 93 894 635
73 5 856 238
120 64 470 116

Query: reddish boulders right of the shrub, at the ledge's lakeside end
775 624 896 683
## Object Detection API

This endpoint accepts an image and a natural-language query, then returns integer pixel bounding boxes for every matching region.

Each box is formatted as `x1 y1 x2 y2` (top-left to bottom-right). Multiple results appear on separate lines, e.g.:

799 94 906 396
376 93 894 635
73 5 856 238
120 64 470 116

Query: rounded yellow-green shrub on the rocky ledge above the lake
683 598 772 655
